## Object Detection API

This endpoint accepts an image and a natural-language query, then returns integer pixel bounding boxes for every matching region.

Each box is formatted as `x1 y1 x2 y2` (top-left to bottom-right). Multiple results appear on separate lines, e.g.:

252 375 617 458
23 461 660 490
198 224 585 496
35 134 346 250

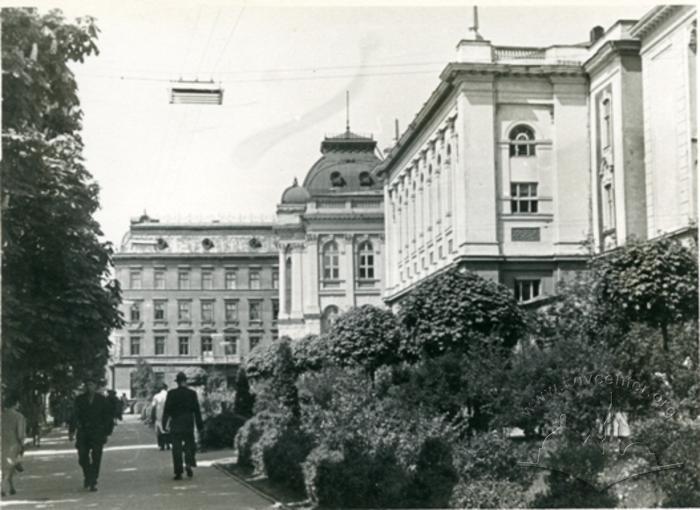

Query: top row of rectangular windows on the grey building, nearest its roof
129 268 279 290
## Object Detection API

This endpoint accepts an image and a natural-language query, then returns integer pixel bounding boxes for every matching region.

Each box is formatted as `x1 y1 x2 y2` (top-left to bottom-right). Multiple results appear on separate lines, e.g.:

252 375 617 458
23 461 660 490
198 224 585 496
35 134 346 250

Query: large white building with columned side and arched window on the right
376 6 697 304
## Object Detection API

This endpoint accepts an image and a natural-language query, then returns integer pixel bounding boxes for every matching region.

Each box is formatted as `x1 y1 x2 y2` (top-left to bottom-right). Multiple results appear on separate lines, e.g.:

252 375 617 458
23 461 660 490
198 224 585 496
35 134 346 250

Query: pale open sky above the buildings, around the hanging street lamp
24 0 651 247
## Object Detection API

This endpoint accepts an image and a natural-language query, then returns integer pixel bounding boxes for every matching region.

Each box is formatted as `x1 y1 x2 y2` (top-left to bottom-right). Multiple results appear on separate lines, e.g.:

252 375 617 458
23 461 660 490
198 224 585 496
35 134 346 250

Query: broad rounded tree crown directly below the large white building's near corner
398 268 525 358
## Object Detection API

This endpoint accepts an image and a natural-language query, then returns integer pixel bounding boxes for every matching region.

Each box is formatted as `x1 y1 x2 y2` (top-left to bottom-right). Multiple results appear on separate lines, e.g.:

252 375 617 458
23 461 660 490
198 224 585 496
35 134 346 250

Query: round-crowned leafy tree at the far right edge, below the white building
594 238 698 351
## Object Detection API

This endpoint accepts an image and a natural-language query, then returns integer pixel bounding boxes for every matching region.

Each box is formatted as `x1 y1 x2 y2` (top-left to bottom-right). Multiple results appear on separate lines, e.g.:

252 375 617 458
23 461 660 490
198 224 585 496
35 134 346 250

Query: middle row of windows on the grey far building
129 299 279 322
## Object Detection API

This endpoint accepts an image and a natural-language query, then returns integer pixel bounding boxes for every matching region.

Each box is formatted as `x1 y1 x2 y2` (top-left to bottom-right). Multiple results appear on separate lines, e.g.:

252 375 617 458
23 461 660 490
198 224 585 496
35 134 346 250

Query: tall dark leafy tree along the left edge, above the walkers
2 5 122 400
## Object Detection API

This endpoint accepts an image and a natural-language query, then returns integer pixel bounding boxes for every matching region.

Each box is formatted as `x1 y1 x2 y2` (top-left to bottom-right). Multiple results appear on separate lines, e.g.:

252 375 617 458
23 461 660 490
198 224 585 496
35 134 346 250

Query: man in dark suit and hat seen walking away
162 372 204 480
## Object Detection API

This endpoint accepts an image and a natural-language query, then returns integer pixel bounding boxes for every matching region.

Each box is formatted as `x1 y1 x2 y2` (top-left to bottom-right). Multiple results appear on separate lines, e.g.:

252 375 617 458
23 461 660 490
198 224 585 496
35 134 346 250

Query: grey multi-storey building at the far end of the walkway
109 215 280 397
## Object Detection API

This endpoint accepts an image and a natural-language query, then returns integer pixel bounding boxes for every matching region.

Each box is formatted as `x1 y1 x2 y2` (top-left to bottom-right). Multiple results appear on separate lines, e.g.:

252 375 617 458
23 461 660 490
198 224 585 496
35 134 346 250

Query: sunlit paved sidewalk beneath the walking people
0 415 272 510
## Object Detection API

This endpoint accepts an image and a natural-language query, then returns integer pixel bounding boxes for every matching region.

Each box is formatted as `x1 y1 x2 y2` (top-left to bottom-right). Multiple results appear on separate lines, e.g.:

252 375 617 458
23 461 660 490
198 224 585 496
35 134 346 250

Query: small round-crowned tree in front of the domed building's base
328 305 399 378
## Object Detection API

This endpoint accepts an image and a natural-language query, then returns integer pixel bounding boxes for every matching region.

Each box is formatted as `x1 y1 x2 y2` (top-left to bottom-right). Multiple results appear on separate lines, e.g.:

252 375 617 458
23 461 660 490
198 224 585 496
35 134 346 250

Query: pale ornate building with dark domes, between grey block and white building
275 129 385 338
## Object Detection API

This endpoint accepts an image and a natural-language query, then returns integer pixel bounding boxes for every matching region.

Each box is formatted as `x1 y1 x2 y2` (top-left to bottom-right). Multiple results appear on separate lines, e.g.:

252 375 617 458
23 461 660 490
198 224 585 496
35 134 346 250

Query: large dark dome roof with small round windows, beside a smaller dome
304 130 382 195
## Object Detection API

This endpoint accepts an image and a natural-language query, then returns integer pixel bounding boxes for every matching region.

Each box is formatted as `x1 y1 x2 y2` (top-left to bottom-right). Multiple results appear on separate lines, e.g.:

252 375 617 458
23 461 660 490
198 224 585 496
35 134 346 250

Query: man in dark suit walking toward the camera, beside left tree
75 380 114 492
